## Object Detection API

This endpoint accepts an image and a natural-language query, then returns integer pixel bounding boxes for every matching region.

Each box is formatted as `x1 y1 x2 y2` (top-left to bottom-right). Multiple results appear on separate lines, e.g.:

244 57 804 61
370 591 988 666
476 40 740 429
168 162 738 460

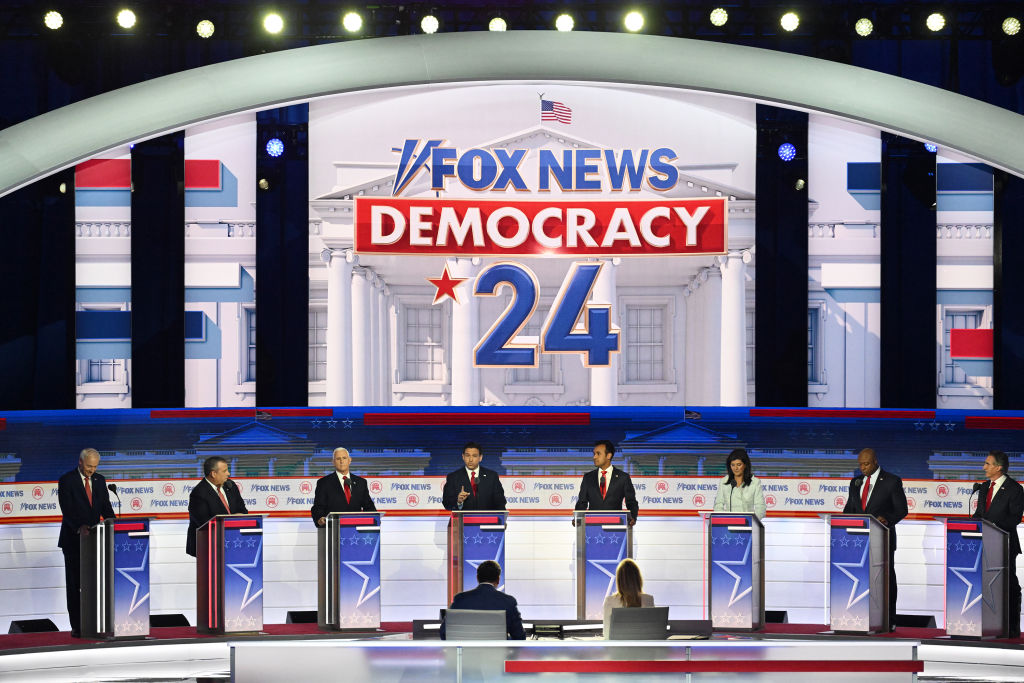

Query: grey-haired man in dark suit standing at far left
57 449 115 638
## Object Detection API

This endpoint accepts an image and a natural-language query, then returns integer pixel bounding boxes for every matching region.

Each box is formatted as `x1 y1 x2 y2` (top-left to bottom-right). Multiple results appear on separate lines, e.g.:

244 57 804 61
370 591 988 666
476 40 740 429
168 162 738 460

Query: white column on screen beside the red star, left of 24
447 258 480 405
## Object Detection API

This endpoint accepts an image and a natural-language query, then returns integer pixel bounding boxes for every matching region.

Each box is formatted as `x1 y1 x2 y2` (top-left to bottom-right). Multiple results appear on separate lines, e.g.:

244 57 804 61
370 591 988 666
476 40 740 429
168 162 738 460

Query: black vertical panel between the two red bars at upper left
130 132 185 408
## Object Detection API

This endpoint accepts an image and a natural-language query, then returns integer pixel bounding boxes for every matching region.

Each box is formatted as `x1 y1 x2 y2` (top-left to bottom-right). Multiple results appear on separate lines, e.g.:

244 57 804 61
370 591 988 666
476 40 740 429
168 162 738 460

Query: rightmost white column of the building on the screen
718 252 750 405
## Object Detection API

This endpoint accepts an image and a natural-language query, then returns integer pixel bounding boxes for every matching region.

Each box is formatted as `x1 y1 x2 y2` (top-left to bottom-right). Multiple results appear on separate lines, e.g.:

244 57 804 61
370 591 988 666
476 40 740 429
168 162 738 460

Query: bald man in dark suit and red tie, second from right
843 449 906 631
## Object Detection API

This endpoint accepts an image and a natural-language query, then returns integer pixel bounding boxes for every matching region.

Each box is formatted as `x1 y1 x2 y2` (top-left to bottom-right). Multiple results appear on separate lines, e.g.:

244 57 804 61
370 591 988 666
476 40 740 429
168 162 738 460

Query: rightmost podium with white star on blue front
945 517 1016 639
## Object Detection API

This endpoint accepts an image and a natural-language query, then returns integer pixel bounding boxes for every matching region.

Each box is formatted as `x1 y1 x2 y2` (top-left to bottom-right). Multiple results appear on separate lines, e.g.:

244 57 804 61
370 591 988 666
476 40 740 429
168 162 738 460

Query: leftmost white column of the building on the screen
321 249 358 405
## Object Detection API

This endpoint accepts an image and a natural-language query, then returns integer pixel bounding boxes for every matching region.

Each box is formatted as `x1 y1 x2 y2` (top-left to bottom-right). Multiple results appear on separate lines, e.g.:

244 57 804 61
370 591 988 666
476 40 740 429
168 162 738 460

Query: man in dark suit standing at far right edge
973 451 1024 638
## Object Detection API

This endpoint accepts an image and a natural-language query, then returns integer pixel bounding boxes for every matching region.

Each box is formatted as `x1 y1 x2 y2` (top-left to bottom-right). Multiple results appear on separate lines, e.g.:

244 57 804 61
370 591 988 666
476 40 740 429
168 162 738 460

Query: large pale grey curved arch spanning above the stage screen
0 31 1024 195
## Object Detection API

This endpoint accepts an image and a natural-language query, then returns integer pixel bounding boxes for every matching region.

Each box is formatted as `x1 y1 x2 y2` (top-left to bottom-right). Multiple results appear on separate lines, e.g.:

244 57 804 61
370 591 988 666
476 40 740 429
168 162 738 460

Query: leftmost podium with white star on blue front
80 519 150 640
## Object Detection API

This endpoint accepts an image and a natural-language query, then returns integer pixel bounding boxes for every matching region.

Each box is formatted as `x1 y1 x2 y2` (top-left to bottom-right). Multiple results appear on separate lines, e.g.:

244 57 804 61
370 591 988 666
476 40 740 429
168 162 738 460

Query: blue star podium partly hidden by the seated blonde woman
573 510 633 621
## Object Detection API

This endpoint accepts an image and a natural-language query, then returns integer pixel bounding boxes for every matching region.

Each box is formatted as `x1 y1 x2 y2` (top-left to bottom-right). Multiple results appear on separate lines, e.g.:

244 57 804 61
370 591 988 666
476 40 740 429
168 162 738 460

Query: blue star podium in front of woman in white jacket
708 512 765 631
